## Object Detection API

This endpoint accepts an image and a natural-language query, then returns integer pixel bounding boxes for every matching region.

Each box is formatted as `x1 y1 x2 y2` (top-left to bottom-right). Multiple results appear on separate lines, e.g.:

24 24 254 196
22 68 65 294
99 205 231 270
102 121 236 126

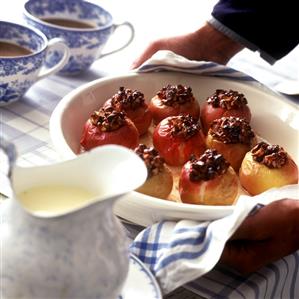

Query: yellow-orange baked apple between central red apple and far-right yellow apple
206 116 257 172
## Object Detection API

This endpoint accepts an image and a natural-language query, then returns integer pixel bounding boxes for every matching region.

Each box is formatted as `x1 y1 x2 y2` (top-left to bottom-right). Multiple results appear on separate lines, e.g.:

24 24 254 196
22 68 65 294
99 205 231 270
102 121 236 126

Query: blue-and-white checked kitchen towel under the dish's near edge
130 184 299 298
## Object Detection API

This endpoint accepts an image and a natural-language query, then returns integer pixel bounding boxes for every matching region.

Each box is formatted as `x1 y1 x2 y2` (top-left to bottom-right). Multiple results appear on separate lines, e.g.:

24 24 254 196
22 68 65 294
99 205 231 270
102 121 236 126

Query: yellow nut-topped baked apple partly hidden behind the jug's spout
135 144 173 199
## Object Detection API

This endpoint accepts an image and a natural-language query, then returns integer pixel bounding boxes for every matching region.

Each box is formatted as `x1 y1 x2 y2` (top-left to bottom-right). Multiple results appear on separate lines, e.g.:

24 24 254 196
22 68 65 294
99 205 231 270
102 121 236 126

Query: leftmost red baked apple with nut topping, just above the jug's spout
80 107 139 150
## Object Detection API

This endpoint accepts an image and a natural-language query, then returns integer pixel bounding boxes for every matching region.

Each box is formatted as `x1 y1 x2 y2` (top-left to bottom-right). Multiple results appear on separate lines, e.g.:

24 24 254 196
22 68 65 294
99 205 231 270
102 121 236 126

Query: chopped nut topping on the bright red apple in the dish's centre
168 114 201 139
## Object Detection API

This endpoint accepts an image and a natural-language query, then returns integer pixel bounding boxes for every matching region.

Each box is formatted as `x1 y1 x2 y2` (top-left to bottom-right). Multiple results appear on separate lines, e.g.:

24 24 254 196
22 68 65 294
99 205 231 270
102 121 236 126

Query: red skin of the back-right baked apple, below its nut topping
200 102 251 134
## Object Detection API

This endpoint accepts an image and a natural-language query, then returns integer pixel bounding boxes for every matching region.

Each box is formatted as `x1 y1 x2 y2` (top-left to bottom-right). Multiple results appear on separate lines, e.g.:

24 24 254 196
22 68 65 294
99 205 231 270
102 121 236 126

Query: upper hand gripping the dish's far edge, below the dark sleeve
131 23 243 69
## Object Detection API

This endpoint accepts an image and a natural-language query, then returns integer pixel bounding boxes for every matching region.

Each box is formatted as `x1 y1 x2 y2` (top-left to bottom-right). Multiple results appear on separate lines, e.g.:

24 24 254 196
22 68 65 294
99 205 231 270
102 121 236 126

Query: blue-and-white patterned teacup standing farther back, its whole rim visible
24 0 134 75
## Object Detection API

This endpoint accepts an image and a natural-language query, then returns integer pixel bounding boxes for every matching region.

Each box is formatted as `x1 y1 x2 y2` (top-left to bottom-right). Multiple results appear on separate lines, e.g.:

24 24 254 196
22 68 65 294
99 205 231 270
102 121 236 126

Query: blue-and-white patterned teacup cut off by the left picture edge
0 21 69 106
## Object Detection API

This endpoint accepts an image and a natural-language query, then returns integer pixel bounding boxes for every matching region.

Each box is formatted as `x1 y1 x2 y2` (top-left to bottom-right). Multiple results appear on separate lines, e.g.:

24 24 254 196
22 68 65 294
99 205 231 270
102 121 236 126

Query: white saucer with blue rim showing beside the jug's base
118 254 162 299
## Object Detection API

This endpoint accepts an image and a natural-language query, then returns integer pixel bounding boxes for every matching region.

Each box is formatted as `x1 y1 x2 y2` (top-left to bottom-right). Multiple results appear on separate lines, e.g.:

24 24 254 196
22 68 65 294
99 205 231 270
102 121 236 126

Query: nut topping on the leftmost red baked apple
89 106 126 132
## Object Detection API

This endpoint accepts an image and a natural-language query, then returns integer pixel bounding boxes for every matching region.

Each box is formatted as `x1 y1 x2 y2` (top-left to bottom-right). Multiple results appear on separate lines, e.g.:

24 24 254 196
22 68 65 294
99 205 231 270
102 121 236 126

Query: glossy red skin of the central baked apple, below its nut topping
153 118 206 166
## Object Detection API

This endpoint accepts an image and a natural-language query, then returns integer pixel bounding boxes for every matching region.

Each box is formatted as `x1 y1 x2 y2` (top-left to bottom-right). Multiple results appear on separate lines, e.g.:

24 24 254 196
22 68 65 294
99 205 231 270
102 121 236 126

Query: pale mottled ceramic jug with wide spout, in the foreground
0 145 147 299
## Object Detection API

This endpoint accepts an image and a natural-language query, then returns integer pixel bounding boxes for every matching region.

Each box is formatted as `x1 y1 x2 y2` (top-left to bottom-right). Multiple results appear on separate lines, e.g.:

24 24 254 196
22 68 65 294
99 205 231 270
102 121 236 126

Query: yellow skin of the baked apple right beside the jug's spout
136 166 173 199
